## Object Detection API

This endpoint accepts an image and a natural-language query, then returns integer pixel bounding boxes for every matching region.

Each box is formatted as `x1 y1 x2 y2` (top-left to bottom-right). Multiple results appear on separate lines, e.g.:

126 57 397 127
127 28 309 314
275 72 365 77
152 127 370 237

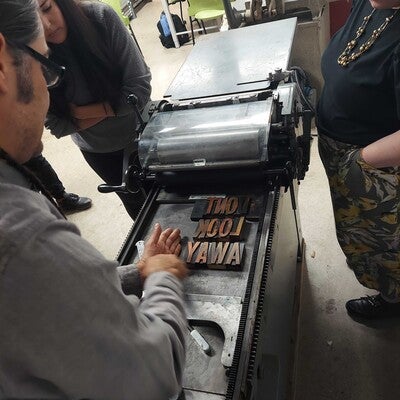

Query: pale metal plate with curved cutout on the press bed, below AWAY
185 294 242 367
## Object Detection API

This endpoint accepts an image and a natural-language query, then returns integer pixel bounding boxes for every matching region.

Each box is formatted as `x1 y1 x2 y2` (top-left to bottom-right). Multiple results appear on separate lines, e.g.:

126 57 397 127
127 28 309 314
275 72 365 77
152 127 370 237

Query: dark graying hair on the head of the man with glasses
0 0 41 45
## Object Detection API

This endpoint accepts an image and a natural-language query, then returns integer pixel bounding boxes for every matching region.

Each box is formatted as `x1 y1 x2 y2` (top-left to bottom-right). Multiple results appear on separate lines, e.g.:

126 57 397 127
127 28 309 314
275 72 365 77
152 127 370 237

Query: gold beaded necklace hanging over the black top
338 8 399 67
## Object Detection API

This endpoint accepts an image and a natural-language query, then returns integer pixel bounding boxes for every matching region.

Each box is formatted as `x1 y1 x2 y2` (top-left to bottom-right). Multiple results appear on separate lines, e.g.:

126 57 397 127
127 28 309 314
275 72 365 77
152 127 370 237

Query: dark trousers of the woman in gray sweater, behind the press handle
81 150 147 219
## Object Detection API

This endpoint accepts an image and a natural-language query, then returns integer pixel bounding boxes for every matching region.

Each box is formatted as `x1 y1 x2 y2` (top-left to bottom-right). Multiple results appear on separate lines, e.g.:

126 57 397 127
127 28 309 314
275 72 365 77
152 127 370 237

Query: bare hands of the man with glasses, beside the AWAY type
137 223 187 279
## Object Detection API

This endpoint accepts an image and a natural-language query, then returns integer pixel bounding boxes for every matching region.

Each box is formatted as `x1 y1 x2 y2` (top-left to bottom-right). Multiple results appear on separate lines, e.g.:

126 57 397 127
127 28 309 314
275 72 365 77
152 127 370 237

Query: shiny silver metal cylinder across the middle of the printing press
139 98 273 171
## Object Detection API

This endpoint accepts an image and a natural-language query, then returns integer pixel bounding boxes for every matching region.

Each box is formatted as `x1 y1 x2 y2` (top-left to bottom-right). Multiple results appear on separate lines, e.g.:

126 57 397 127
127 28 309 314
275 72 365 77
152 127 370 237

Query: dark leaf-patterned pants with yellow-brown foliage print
318 135 400 299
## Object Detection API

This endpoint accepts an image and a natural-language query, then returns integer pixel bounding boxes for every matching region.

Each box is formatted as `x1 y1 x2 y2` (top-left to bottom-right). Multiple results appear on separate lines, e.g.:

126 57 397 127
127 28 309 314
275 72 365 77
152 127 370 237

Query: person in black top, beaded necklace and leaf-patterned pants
318 0 400 318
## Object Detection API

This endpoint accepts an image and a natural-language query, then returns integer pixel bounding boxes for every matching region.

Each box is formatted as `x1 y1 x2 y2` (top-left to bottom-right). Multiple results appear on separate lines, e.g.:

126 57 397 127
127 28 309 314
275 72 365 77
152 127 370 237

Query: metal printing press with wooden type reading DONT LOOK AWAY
114 19 311 400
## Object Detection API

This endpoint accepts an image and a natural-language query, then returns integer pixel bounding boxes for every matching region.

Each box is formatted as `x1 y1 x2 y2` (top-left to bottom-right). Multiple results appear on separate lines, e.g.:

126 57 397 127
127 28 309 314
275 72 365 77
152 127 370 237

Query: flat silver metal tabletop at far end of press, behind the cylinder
165 18 296 100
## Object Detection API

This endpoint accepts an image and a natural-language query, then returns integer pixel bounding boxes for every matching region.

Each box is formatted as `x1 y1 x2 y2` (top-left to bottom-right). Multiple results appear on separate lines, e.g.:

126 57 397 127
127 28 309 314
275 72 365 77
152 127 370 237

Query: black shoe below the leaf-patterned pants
346 294 400 319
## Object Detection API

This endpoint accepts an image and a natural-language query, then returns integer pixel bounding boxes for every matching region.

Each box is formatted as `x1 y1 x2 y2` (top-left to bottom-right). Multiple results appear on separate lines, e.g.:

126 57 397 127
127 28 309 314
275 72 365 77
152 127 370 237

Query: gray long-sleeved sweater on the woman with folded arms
46 1 151 153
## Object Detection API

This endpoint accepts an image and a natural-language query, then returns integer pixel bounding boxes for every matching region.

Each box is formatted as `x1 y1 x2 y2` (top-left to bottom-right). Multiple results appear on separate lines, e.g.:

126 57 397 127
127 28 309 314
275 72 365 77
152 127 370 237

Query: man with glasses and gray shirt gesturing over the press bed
0 0 186 400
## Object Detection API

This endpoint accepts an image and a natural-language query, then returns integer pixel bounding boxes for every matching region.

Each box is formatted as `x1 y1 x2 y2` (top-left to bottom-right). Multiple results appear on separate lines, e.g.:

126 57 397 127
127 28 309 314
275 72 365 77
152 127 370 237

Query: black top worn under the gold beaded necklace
317 0 400 146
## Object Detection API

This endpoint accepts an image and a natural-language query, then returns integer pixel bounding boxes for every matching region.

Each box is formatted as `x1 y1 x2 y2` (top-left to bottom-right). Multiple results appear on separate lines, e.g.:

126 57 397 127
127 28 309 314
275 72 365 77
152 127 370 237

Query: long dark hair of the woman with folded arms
48 0 122 119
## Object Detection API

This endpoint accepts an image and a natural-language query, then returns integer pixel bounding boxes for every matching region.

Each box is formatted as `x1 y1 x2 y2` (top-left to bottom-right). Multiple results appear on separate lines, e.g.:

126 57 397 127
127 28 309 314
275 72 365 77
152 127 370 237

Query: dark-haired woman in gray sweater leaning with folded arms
38 0 151 219
